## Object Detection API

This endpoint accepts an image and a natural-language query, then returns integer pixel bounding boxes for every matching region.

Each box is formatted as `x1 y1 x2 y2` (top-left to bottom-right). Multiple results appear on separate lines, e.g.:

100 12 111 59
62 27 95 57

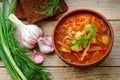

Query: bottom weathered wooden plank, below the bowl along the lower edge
0 67 120 80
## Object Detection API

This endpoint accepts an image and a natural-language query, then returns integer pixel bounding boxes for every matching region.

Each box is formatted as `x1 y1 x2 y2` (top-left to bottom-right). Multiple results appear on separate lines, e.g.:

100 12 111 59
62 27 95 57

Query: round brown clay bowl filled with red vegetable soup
52 9 114 67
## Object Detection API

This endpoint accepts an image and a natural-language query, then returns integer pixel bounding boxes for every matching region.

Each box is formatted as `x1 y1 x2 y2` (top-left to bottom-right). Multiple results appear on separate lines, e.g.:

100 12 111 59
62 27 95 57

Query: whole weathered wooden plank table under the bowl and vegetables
0 0 120 80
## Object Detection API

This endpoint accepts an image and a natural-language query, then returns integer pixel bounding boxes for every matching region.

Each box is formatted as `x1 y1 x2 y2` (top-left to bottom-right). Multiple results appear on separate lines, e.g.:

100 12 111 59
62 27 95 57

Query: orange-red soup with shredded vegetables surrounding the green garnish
55 13 111 64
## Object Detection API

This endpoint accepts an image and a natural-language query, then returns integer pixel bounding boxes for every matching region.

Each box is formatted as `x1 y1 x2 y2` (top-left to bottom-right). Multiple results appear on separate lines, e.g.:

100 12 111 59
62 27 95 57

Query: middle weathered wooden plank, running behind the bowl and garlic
0 21 120 66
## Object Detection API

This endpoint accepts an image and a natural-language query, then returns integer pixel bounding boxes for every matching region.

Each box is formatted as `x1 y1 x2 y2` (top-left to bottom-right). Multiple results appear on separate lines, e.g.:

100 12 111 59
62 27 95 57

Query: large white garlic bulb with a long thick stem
8 14 43 49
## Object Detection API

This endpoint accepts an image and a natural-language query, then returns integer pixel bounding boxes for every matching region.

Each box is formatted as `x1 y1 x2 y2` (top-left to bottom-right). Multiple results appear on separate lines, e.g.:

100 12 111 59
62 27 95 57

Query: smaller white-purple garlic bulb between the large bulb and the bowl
38 37 54 53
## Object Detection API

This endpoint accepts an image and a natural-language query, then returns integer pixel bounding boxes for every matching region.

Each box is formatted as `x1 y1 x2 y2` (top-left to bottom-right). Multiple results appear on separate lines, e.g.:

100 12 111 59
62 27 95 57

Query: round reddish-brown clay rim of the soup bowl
52 9 114 67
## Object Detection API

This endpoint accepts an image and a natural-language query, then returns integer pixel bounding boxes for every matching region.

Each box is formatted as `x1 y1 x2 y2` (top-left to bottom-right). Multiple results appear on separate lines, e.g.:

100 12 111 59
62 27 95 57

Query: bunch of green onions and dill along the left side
0 0 50 80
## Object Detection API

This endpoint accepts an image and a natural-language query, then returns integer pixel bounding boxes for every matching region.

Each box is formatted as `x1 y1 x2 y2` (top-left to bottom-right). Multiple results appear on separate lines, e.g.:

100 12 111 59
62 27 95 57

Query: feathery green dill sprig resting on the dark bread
34 0 60 16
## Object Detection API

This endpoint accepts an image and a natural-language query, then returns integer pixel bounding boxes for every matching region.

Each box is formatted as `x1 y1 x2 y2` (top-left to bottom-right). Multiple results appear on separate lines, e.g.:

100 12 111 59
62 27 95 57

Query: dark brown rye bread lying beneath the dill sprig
15 0 68 24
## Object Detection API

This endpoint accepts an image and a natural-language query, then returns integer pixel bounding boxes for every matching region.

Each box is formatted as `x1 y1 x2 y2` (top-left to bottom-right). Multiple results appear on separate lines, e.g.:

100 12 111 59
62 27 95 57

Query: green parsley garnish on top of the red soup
68 24 97 48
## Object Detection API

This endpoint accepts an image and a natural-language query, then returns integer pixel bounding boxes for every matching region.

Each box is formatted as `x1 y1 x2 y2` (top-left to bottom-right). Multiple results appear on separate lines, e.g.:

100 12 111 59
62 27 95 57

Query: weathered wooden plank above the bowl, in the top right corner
65 0 120 19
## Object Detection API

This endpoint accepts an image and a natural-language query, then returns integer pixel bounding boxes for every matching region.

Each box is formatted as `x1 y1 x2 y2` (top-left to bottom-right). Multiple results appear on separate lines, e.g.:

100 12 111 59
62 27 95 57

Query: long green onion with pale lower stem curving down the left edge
0 0 26 80
